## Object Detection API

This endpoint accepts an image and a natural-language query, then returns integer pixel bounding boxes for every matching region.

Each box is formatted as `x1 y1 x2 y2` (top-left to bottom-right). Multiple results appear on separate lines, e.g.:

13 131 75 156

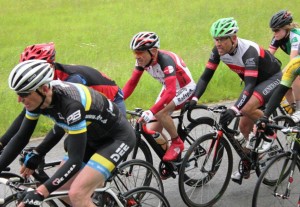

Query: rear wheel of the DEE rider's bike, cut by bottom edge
122 187 170 207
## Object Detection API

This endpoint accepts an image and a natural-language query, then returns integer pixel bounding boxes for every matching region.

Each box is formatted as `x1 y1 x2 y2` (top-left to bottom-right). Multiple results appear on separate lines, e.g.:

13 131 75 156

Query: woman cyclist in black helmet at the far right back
269 10 300 119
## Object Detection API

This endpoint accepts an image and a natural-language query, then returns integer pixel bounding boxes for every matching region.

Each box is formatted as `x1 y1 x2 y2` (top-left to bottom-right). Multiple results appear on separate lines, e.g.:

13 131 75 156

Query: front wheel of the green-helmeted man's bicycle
179 133 233 207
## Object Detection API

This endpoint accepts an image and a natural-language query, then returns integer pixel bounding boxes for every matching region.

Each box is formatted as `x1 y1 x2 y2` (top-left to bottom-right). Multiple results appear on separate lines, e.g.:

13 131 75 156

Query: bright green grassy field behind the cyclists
0 0 300 136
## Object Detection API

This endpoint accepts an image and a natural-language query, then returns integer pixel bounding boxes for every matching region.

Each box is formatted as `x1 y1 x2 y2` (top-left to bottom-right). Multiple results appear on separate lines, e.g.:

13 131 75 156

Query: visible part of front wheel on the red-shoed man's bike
127 138 153 165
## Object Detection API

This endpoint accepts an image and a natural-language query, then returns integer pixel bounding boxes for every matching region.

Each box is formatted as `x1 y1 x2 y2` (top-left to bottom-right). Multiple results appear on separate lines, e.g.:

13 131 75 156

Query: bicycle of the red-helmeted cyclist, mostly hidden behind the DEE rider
0 147 164 206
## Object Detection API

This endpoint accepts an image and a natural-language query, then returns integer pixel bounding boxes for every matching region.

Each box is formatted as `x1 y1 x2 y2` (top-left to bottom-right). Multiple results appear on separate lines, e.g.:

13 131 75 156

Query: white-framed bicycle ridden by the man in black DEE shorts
0 176 170 207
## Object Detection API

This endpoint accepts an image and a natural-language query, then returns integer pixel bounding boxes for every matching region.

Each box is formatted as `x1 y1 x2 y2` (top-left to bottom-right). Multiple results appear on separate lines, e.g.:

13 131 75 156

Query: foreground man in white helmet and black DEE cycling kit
0 60 135 207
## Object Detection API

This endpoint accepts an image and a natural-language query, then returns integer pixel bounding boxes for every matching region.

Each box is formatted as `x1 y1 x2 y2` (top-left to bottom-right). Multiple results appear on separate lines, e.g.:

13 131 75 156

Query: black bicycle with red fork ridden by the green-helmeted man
179 105 285 207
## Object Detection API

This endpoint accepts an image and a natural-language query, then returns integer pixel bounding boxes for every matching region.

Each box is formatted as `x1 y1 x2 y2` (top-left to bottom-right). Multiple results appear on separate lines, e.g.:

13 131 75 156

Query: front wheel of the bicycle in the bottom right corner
252 152 300 207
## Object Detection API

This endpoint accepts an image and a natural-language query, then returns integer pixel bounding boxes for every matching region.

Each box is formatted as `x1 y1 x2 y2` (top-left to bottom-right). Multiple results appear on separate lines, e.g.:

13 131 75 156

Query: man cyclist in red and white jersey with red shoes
123 32 196 161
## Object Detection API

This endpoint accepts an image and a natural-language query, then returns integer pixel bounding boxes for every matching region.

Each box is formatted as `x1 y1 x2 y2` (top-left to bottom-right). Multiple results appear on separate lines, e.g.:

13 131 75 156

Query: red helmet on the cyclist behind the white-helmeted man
20 42 55 63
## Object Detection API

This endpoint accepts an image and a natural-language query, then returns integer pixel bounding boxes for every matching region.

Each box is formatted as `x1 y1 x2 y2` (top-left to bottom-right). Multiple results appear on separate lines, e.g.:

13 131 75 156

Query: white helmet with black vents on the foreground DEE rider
8 60 54 92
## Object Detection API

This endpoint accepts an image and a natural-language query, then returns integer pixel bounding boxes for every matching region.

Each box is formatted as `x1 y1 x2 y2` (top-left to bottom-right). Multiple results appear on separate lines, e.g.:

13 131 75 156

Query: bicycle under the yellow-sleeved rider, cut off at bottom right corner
252 116 300 207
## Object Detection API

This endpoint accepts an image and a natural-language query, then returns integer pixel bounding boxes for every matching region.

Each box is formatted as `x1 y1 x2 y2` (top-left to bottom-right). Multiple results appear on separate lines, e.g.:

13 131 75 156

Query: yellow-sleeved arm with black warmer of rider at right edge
258 45 300 125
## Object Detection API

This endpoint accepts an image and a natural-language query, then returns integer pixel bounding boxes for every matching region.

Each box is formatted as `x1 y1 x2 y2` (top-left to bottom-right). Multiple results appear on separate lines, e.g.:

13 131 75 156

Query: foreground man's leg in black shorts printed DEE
69 118 135 206
